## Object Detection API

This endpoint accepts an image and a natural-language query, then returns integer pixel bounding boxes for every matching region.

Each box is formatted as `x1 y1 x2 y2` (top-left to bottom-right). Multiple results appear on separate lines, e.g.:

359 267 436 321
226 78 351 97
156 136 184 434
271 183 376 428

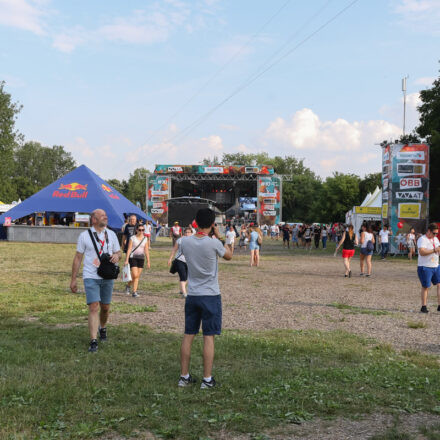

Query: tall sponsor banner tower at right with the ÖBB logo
382 144 429 253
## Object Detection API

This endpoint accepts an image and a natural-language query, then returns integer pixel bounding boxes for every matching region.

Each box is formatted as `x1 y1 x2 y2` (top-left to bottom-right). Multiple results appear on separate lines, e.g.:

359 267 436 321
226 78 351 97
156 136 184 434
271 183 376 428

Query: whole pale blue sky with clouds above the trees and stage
0 0 440 178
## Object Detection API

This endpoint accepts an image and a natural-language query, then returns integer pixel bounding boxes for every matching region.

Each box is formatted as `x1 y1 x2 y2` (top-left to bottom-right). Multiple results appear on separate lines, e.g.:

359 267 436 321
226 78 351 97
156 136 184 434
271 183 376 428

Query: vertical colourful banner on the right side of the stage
258 176 281 225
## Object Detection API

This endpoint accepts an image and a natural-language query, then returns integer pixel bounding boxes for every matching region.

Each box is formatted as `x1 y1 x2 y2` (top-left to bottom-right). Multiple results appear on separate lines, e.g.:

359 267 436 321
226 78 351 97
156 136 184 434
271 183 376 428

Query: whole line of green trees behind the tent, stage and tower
0 64 440 222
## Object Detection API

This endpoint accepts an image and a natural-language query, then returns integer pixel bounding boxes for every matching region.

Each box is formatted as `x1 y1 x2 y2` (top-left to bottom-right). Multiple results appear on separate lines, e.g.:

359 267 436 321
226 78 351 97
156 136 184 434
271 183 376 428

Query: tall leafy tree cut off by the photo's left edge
0 81 22 202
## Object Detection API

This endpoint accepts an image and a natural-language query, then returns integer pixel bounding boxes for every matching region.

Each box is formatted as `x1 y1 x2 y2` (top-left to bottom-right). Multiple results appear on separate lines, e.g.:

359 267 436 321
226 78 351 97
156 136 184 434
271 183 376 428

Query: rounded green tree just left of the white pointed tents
320 172 361 222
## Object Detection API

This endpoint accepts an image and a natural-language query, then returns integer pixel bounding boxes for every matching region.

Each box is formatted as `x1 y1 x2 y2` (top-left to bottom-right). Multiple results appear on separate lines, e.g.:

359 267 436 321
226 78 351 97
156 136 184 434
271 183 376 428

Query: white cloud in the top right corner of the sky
392 0 440 35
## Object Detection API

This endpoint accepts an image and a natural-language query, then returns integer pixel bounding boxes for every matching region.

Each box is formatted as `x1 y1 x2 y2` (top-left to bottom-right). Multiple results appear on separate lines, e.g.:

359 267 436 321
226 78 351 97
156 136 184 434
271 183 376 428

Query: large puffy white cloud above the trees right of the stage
263 108 401 176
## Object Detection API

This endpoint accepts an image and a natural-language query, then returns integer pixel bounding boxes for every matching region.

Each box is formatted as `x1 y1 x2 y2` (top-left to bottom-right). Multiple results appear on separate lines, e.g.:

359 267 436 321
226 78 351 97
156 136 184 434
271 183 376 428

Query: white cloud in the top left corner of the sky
0 0 45 35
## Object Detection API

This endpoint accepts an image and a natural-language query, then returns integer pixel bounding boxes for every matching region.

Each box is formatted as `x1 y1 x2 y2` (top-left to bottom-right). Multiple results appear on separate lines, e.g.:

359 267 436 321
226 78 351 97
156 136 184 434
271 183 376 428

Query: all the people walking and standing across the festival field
70 208 440 389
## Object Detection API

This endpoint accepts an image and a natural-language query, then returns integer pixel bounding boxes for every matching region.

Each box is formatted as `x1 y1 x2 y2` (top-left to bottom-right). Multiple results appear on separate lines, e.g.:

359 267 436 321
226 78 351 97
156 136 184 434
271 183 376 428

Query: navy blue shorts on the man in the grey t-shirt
185 295 222 336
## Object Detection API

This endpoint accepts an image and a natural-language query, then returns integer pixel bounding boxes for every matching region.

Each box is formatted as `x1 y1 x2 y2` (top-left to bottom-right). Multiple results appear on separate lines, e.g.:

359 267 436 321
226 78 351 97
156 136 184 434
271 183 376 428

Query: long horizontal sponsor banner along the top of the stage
154 165 274 176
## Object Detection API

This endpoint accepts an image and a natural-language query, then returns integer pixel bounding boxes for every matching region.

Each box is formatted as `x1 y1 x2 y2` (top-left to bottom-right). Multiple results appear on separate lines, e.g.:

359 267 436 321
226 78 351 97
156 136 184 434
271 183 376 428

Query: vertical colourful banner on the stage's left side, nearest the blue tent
147 174 171 223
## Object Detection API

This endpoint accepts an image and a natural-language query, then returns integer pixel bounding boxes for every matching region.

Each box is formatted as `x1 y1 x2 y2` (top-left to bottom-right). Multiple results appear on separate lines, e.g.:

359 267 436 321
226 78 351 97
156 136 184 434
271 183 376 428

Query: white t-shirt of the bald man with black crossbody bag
76 226 120 280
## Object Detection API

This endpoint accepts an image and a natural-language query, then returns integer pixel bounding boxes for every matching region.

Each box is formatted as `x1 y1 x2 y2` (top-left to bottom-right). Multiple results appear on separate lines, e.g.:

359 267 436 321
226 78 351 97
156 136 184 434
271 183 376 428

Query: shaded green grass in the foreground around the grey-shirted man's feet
0 319 440 439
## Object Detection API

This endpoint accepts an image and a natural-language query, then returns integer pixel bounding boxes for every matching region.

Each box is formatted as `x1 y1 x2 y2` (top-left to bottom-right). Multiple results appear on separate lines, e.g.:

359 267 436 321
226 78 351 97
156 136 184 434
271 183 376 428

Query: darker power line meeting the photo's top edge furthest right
168 0 359 142
